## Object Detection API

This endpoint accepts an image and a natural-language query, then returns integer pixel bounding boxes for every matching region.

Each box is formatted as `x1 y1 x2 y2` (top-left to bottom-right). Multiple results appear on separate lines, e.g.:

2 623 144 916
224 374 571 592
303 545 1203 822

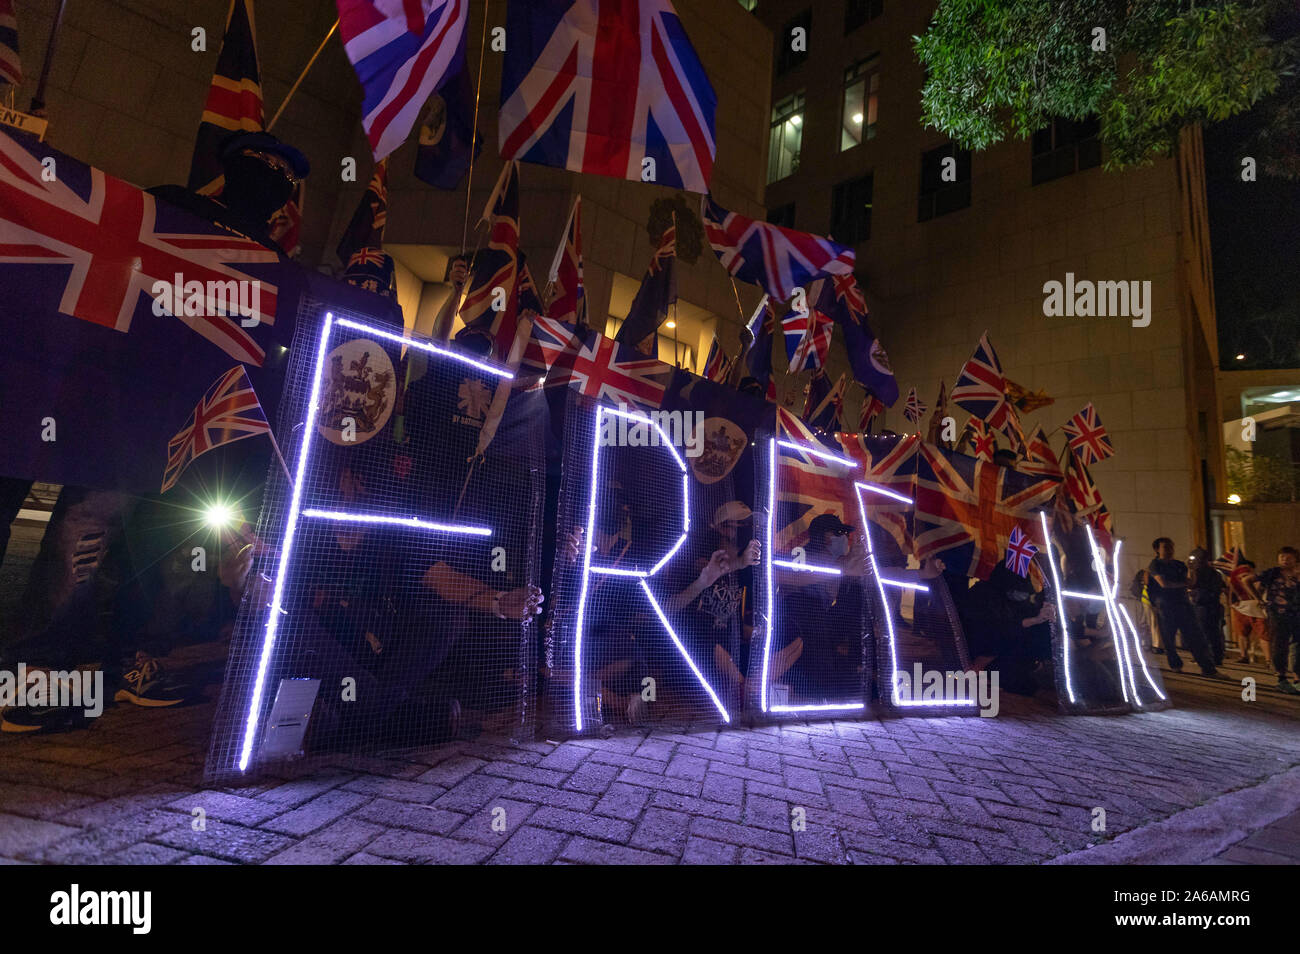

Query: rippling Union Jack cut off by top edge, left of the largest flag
338 0 469 159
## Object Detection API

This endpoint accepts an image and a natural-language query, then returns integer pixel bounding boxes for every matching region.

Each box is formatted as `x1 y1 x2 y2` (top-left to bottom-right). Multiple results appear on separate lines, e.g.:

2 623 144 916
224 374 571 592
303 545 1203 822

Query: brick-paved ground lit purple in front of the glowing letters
0 647 1300 864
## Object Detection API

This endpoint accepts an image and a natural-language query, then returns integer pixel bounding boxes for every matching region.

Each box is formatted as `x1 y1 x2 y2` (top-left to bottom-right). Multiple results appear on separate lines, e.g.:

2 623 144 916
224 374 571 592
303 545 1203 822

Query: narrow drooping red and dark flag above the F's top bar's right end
460 162 519 357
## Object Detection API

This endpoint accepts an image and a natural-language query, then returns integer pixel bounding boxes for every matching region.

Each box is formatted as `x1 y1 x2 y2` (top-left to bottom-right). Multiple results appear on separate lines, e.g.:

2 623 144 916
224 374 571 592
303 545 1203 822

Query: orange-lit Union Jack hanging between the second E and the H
914 443 1057 580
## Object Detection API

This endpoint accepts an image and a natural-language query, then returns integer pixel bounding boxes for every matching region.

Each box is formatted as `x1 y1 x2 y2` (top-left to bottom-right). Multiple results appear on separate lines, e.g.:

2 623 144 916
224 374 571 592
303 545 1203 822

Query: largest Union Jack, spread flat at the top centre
499 0 718 192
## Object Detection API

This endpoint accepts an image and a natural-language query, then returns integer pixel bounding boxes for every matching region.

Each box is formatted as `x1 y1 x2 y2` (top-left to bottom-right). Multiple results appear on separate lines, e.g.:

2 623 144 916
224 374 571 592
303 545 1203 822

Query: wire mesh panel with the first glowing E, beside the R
749 435 875 719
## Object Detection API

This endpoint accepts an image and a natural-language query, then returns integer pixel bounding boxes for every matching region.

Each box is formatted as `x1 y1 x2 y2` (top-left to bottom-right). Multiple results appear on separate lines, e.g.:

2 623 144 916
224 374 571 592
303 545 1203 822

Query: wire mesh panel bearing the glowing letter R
549 393 753 734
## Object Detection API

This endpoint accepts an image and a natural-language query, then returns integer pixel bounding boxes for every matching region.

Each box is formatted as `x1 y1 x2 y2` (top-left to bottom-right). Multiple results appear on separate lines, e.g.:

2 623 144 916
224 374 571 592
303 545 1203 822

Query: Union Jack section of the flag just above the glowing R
538 327 673 409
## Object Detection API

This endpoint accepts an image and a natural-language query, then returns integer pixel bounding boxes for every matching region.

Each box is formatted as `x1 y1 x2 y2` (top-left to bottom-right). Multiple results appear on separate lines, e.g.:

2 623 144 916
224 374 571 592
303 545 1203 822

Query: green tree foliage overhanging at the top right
914 0 1300 174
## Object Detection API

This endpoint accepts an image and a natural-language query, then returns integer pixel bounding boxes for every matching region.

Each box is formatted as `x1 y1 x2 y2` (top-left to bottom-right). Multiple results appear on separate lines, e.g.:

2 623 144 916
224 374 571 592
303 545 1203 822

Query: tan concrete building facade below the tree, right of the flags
754 0 1225 574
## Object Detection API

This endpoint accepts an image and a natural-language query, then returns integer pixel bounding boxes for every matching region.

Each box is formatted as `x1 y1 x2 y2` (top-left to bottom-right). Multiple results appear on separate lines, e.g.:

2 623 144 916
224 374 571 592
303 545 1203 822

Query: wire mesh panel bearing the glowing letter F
208 299 546 779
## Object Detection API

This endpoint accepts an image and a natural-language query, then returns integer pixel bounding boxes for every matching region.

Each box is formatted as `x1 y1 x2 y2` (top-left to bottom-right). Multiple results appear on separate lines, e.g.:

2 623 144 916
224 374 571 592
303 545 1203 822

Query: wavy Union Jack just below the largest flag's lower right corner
702 195 857 302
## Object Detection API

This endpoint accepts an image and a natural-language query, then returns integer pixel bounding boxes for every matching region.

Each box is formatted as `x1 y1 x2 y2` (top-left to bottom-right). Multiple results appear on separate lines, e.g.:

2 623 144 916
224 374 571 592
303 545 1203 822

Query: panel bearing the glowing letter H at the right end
1035 515 1170 715
